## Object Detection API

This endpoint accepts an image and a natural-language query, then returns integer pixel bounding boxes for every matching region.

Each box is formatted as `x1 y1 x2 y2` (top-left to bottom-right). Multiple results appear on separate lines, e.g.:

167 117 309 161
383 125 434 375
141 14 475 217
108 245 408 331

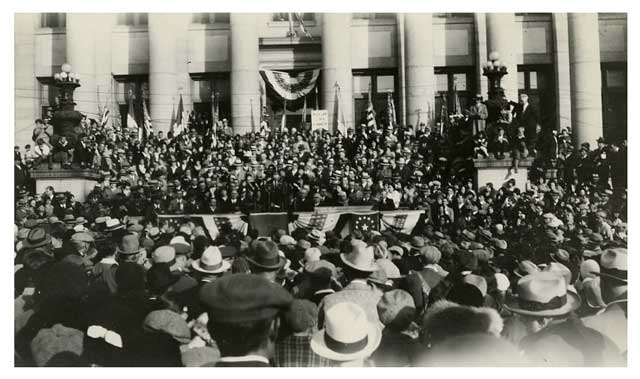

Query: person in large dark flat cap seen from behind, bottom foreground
200 274 293 367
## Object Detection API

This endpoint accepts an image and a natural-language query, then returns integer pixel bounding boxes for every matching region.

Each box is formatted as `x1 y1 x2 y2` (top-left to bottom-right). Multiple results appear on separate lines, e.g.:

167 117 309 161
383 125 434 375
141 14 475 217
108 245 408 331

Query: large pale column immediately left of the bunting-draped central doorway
230 13 261 134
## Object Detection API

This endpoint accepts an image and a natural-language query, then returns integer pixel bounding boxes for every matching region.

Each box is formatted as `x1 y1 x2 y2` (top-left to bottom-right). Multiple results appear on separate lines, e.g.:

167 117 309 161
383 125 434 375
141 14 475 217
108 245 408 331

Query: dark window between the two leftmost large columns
115 75 149 128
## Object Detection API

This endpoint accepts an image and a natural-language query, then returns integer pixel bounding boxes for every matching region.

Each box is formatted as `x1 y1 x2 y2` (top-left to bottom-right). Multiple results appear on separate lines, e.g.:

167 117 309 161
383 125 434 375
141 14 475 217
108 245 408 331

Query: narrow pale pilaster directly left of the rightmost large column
552 13 571 130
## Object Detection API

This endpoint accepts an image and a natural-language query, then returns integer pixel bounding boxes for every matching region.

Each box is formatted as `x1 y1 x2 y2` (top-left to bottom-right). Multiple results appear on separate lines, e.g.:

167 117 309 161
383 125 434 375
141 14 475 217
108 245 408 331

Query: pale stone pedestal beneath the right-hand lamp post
473 156 533 191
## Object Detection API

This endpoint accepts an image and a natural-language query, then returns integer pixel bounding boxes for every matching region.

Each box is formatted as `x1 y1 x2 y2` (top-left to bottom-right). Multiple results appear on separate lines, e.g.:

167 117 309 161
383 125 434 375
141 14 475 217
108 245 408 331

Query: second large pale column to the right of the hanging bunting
404 13 435 128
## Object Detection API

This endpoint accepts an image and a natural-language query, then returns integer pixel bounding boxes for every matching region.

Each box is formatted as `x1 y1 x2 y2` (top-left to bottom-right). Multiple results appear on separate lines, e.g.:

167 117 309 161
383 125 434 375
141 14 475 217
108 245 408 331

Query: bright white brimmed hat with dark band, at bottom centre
311 302 382 361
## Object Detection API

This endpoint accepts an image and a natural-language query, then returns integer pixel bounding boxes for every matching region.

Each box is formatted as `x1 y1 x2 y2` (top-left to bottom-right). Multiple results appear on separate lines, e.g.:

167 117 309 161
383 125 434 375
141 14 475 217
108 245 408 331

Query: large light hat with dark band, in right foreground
504 272 581 317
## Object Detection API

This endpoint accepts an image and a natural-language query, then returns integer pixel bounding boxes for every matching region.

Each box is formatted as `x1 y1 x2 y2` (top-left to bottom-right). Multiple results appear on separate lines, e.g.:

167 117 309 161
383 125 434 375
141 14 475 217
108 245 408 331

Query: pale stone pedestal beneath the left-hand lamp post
31 168 100 202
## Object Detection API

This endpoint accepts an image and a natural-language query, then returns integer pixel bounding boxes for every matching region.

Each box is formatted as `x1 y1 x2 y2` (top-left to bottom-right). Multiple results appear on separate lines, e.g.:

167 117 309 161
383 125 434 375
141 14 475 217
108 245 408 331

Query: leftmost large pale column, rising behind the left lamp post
66 13 100 119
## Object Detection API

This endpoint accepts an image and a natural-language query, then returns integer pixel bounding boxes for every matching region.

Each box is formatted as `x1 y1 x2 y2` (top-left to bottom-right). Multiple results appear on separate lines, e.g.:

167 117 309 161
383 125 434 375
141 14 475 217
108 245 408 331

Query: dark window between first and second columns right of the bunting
352 70 399 125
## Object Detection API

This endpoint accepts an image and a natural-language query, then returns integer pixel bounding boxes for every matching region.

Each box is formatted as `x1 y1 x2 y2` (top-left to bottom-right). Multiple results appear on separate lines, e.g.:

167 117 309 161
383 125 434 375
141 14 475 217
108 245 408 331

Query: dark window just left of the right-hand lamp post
435 67 475 122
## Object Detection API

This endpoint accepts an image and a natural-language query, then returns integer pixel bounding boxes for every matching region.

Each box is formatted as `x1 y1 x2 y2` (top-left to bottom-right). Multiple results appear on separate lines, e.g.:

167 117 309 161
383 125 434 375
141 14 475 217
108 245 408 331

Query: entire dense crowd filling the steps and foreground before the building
14 91 627 367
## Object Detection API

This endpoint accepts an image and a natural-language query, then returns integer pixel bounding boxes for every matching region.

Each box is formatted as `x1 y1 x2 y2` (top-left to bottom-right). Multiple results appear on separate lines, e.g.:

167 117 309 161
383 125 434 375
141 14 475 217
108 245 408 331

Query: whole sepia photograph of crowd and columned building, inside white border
11 4 637 370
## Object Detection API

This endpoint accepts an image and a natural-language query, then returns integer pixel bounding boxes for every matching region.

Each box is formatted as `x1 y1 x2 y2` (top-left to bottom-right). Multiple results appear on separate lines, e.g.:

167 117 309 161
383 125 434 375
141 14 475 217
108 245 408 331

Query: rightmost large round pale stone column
568 13 602 146
